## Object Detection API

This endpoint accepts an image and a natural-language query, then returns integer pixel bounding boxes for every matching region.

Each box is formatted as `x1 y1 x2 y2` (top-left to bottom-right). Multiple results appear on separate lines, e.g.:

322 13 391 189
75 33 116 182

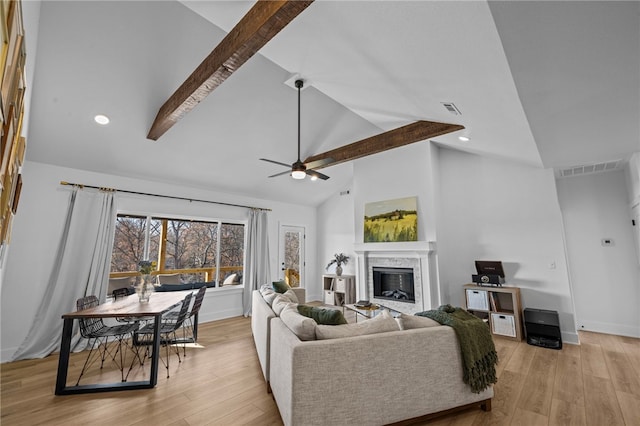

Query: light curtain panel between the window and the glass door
242 209 271 317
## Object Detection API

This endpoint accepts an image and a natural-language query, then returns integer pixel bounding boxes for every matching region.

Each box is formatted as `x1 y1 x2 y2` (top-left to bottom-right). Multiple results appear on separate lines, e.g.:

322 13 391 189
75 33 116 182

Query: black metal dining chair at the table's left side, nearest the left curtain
76 296 139 386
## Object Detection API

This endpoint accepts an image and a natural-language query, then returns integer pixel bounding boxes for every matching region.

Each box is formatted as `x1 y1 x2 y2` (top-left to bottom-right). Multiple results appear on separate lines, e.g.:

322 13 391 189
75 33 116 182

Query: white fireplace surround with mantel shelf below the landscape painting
354 241 440 313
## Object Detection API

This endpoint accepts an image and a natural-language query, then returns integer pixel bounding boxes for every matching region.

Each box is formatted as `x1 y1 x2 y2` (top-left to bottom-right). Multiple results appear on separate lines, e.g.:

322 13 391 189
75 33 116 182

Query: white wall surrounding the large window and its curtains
0 161 320 361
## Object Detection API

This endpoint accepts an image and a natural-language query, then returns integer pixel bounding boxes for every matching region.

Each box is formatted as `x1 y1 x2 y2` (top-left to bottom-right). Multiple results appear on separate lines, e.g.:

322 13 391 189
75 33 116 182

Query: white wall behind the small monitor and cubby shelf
437 149 577 342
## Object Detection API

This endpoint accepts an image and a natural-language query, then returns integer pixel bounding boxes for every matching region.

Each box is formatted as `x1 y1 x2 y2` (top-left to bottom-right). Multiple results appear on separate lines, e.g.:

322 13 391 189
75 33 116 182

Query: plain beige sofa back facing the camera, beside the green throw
269 318 493 425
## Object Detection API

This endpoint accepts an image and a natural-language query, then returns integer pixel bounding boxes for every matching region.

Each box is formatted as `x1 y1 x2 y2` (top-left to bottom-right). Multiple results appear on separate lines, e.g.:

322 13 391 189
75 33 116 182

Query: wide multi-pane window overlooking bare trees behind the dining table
110 215 245 286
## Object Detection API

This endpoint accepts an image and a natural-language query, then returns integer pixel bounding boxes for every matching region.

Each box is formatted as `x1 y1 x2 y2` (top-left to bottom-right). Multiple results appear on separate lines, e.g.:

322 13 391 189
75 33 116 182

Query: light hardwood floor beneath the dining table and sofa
0 317 640 426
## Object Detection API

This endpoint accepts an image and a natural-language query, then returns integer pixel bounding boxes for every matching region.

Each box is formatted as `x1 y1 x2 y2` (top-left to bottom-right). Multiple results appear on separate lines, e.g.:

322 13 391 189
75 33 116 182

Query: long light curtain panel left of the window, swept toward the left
13 187 117 361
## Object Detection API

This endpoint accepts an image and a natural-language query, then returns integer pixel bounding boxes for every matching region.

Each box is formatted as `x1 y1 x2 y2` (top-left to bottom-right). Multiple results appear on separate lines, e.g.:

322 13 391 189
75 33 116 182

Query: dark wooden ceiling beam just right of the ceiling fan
304 120 464 169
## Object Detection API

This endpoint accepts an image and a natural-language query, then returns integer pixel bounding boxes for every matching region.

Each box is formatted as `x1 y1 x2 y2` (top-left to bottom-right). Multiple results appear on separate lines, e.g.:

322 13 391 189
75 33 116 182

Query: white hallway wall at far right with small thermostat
557 170 640 337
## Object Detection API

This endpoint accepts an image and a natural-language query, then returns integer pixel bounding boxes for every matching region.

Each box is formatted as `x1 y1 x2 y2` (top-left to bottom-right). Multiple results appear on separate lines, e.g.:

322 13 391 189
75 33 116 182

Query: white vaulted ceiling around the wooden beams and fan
27 0 640 205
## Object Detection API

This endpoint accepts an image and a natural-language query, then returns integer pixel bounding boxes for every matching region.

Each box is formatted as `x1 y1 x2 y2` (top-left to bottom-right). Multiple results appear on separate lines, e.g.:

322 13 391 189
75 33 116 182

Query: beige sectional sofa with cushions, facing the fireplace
251 290 493 425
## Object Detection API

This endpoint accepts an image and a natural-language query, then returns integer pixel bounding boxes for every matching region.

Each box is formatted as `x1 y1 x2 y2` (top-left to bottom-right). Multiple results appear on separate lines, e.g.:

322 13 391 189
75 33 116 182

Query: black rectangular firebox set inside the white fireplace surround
372 266 416 303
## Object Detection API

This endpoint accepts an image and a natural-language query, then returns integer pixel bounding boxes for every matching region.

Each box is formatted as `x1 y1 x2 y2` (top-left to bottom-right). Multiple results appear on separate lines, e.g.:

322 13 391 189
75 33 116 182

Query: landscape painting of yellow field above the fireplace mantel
364 197 418 243
